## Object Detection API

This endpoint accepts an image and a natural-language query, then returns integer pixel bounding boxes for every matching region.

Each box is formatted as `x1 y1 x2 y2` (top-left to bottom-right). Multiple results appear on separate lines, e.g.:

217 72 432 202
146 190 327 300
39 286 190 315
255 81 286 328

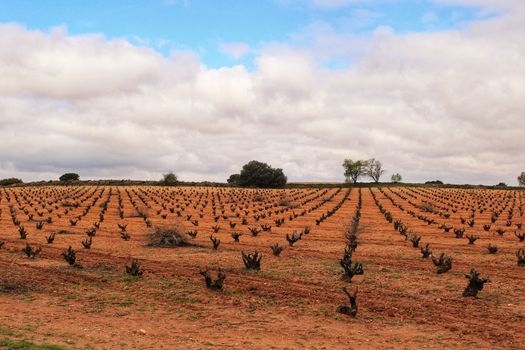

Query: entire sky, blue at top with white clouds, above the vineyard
0 0 525 185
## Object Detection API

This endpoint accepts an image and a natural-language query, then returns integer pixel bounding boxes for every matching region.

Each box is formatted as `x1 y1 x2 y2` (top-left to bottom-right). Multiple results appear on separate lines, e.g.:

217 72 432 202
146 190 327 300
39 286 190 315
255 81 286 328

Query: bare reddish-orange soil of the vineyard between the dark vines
0 187 525 349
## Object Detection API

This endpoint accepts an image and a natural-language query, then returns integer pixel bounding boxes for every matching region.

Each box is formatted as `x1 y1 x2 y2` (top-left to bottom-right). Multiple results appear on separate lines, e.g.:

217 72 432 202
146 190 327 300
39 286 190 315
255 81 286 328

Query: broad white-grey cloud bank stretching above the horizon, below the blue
0 0 525 183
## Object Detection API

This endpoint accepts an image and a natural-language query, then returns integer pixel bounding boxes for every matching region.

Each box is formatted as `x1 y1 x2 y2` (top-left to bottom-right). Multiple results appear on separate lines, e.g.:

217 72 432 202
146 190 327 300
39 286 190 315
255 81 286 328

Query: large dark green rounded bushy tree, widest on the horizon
236 160 288 188
